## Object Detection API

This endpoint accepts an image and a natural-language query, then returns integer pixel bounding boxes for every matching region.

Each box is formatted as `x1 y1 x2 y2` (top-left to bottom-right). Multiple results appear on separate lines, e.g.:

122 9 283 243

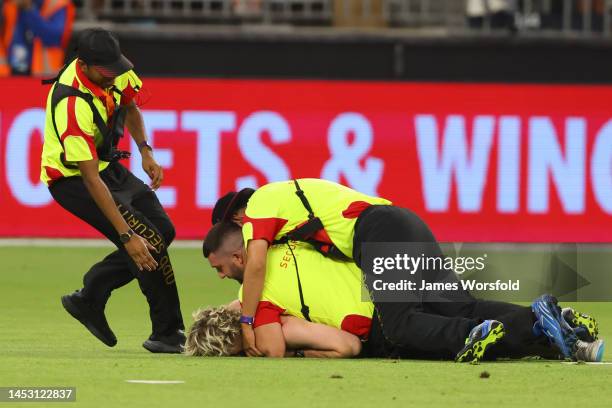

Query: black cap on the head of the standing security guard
77 28 134 78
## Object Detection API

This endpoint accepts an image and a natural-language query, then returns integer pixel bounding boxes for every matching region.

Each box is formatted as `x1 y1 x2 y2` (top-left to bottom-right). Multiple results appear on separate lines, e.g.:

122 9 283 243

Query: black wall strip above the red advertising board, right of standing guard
67 31 612 83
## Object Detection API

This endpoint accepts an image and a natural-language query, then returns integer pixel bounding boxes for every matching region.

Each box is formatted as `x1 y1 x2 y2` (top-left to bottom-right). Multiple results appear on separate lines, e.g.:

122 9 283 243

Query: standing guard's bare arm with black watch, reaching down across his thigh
79 159 157 271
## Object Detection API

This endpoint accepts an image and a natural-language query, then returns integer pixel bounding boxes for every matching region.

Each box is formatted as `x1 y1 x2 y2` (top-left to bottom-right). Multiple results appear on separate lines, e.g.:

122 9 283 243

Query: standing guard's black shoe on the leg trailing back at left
62 290 117 347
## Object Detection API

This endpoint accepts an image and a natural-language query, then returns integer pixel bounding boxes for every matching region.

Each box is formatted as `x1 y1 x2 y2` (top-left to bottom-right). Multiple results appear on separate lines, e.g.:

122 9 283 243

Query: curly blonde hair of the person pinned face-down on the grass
184 306 240 357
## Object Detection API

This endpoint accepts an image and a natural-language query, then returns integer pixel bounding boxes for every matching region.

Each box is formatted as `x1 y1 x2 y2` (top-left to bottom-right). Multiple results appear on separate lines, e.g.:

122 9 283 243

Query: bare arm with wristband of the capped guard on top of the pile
242 239 268 357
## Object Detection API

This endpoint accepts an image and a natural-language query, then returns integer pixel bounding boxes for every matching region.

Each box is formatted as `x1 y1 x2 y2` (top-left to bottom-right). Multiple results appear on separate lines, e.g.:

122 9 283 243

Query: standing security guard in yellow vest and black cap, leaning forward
41 29 185 353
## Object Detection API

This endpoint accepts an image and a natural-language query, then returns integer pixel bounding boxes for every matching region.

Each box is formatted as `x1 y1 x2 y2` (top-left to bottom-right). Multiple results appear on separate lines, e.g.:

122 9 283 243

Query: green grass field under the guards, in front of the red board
0 247 612 408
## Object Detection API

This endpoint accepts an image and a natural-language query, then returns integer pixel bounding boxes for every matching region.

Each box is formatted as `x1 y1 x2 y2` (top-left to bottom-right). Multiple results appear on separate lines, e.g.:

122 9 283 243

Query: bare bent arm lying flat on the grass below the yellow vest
282 316 361 358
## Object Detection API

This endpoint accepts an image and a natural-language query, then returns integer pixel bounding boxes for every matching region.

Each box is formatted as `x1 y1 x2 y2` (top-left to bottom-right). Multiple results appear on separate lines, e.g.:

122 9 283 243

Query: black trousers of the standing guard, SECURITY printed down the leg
49 162 185 336
